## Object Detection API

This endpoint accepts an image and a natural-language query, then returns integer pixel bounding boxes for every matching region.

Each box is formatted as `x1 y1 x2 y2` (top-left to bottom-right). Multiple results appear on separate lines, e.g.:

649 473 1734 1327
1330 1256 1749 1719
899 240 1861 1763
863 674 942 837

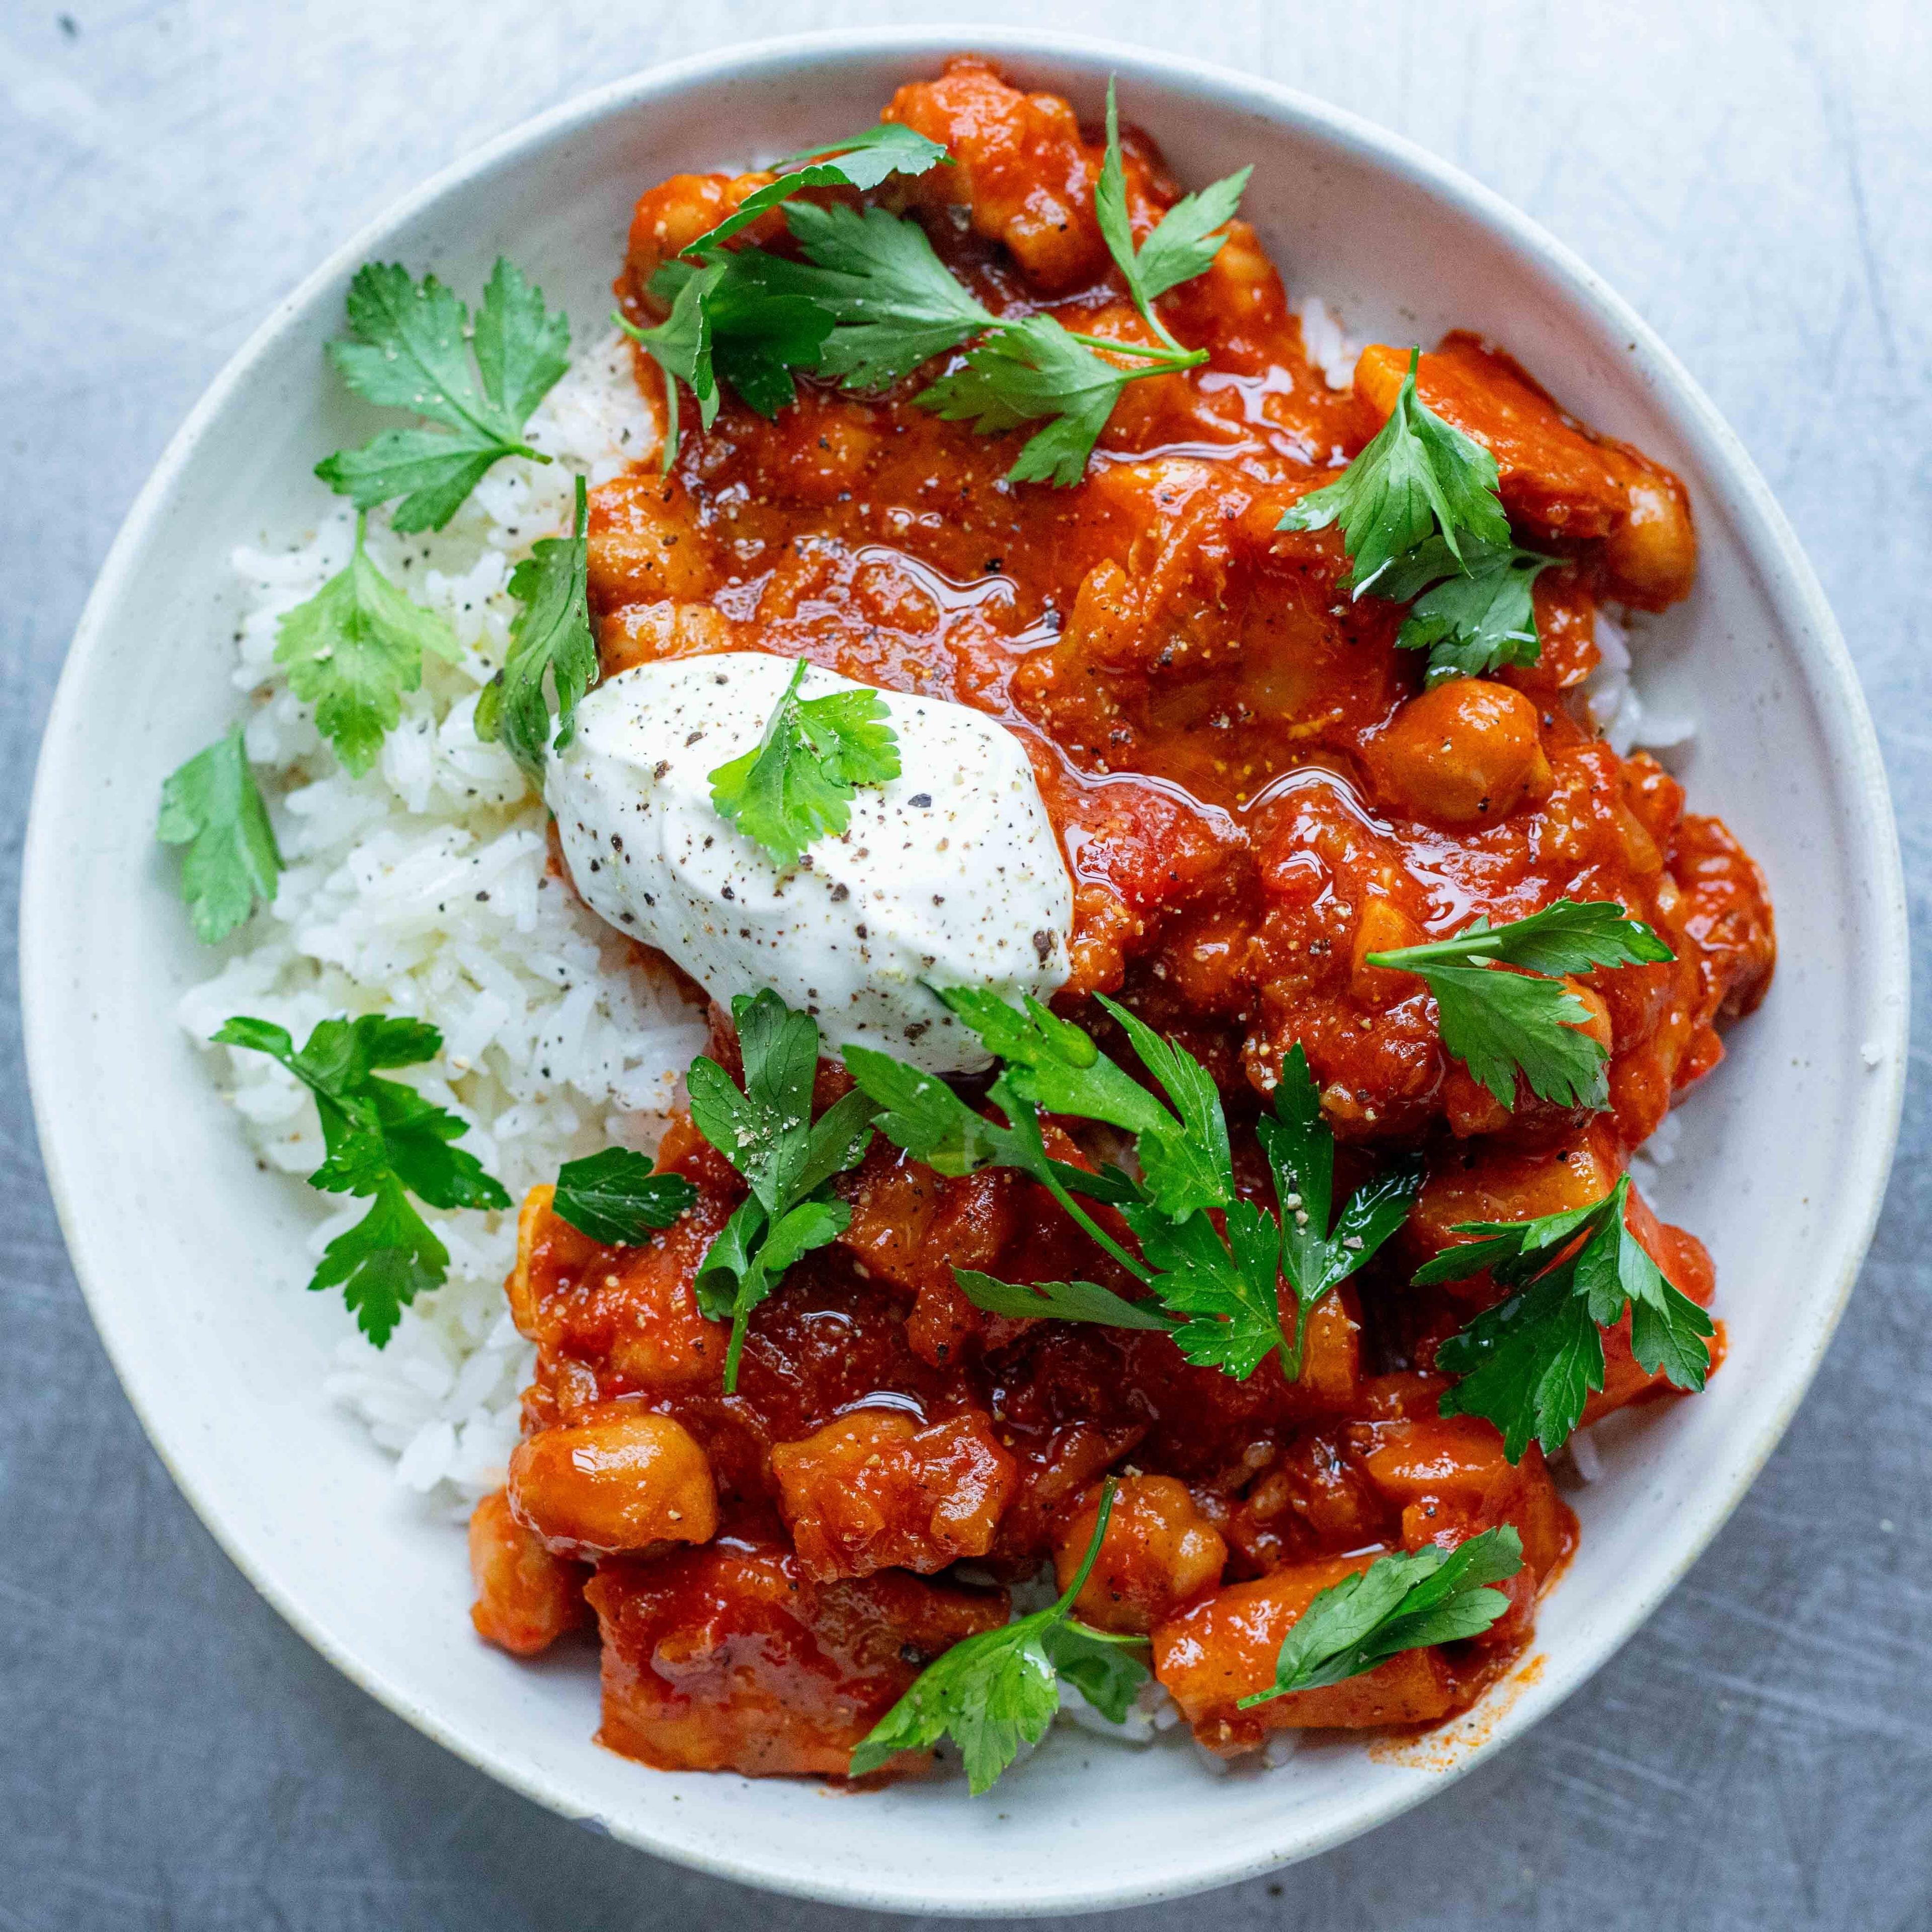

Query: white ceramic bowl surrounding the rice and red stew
21 29 1907 1914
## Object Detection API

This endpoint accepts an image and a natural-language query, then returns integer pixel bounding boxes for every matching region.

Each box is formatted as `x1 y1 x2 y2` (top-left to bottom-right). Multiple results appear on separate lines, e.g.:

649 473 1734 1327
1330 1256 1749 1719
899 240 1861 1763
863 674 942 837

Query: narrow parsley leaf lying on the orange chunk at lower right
1240 1522 1522 1710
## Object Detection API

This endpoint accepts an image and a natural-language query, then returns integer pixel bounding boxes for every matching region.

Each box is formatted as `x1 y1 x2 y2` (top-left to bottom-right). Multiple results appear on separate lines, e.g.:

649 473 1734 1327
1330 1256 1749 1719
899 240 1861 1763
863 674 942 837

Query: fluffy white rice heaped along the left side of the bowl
180 334 703 1511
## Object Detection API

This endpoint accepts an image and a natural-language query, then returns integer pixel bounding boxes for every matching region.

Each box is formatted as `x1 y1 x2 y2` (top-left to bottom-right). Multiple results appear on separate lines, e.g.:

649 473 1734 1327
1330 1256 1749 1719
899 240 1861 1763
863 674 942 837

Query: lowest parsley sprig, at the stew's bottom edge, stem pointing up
852 1482 1148 1797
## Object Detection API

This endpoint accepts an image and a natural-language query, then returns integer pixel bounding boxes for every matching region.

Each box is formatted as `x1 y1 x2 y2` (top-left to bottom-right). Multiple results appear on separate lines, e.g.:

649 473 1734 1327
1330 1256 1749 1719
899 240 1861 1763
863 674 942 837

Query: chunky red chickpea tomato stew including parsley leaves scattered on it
471 60 1776 1785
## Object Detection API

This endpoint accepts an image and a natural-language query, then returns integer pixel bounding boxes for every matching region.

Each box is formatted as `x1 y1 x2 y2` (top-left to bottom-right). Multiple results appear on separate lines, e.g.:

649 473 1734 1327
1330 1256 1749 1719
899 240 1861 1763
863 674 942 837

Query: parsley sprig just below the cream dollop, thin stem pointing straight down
686 987 875 1393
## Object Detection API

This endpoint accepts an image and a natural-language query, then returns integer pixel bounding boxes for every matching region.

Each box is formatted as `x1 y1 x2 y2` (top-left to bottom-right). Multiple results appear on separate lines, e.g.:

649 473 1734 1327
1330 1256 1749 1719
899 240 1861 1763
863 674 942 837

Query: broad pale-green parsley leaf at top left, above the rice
315 257 570 531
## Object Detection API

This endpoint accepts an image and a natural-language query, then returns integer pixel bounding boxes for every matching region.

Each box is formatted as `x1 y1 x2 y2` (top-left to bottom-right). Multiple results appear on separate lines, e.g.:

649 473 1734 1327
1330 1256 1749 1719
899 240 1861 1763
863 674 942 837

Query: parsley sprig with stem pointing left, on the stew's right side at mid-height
1368 899 1677 1109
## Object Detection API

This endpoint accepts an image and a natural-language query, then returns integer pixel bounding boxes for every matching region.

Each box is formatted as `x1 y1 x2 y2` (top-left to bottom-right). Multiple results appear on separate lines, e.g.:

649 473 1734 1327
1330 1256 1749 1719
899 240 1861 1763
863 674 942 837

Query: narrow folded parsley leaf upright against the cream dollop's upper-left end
475 477 597 779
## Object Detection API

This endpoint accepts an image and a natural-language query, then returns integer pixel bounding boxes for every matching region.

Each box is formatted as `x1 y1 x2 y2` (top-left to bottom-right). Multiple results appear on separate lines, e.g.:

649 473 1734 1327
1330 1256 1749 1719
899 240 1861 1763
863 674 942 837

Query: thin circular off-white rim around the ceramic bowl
18 21 1911 1914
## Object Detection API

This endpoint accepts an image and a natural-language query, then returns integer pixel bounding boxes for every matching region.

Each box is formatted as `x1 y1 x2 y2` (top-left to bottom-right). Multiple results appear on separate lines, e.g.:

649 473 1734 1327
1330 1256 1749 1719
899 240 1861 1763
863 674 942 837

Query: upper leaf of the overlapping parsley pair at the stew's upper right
1275 352 1509 597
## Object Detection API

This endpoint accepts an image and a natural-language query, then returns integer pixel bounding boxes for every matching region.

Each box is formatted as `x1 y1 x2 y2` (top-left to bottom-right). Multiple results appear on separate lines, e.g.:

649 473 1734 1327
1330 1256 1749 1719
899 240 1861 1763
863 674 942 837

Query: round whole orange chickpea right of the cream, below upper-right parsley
1372 678 1550 825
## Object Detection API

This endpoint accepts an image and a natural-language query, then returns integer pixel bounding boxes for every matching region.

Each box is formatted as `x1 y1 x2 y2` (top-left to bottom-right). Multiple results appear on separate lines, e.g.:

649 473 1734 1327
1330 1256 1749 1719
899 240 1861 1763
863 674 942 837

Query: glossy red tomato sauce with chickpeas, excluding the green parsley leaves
473 62 1776 1774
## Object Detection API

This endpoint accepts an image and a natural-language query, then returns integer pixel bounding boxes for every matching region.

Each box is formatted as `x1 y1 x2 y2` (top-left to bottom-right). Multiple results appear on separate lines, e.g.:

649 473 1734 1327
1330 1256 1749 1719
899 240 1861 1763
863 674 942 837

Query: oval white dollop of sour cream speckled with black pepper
545 651 1072 1074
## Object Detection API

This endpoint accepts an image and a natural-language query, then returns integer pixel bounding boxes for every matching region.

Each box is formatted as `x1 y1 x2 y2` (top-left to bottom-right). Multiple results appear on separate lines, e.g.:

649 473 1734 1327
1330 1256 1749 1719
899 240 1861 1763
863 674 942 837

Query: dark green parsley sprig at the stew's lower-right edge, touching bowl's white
1416 1175 1716 1463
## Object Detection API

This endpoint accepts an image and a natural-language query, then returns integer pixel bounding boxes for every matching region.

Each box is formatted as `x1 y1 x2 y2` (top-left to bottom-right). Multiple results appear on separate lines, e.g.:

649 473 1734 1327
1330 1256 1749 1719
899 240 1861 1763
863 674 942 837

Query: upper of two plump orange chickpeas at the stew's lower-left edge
510 1403 718 1555
